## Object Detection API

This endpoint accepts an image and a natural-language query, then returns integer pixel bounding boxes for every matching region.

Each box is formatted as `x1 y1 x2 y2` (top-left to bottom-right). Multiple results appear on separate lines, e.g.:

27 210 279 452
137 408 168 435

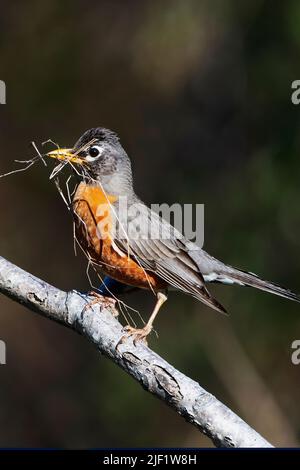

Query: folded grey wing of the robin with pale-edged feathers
114 203 226 313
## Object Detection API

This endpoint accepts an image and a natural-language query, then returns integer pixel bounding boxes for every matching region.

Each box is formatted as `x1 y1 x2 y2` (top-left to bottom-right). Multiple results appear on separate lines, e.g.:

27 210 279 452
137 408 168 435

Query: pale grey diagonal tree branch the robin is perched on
0 257 272 447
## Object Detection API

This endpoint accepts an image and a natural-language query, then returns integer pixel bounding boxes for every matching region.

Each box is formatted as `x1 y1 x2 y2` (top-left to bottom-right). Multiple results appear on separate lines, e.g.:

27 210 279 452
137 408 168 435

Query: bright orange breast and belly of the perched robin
73 183 166 290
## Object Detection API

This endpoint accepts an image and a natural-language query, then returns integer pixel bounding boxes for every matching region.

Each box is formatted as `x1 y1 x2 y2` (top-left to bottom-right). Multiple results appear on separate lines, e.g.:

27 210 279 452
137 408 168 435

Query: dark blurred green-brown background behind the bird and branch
0 0 300 448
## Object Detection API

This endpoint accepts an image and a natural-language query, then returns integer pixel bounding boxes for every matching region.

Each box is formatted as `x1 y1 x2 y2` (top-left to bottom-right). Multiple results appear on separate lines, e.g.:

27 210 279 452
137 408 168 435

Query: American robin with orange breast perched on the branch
48 127 300 340
